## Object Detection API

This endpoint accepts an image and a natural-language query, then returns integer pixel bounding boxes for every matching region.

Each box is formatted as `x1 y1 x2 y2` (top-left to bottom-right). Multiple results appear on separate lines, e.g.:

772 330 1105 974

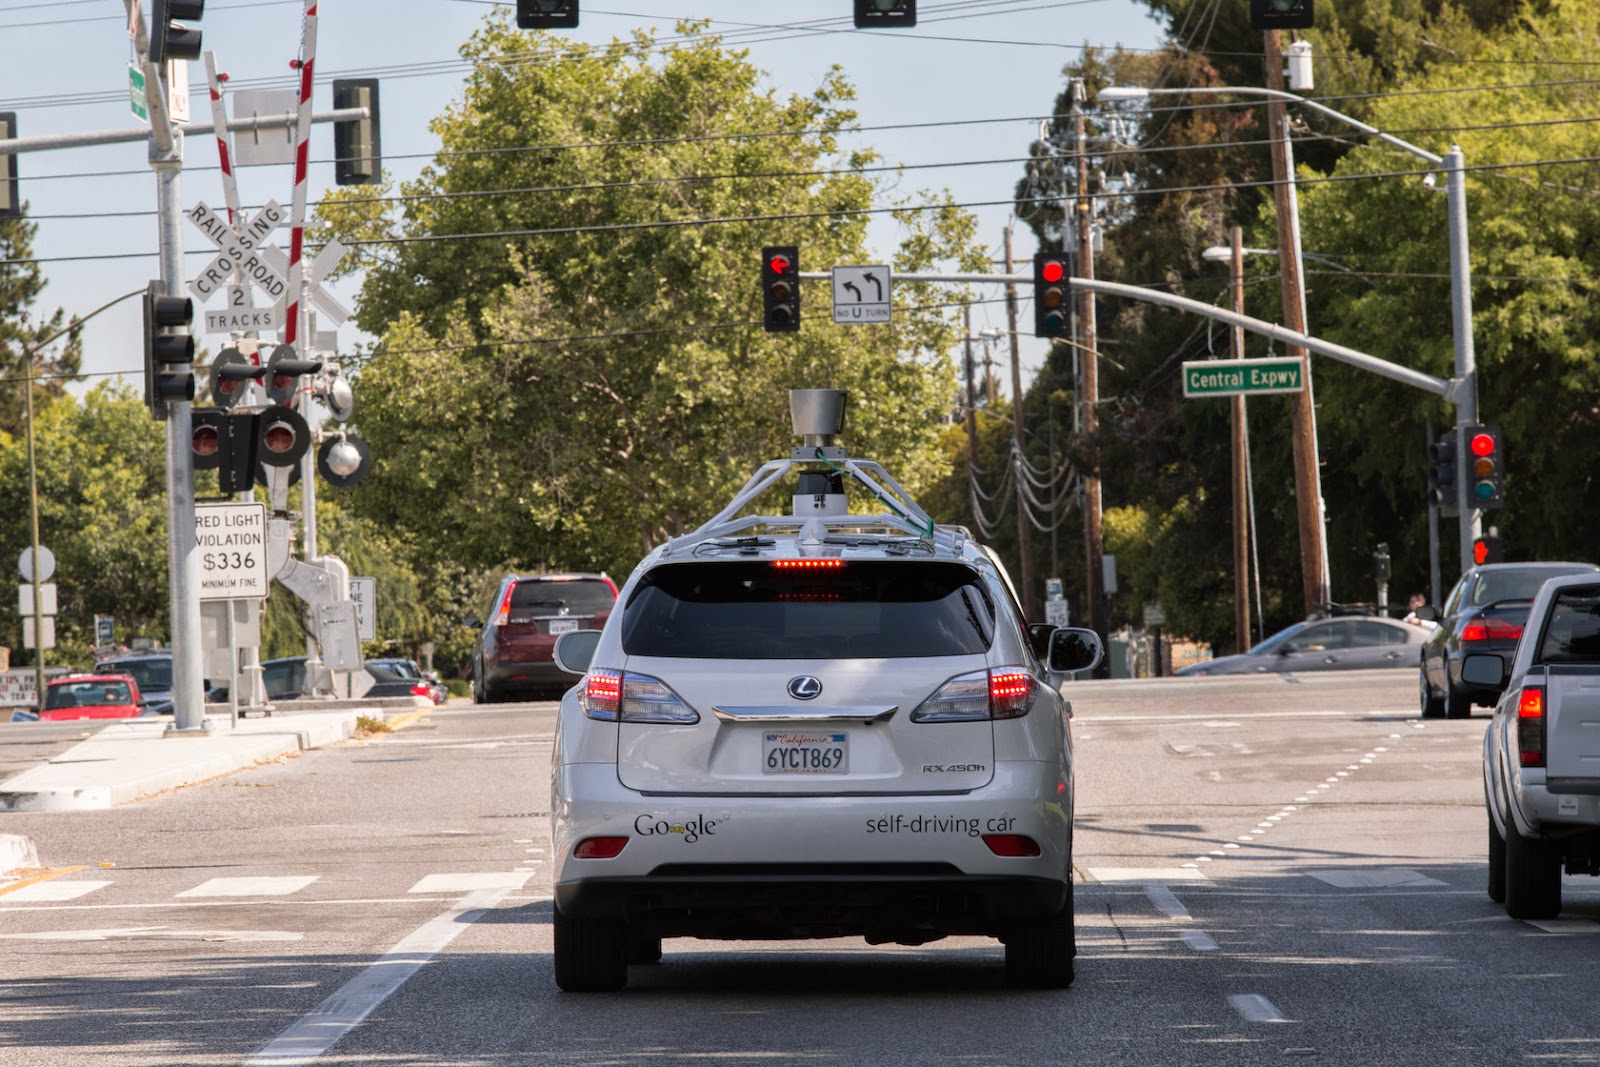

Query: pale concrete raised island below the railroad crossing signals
0 701 432 819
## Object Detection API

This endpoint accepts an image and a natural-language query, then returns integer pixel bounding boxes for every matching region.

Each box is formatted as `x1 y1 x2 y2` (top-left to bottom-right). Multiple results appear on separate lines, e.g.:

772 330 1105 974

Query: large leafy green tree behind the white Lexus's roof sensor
323 16 982 576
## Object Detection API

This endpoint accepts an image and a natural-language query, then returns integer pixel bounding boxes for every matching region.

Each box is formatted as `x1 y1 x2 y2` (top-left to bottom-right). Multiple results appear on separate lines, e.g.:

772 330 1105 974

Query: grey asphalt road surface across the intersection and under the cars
0 670 1600 1067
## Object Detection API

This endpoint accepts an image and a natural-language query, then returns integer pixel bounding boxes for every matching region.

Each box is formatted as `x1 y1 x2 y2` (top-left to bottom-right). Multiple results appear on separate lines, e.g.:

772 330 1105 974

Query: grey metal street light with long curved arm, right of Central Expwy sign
1099 85 1483 571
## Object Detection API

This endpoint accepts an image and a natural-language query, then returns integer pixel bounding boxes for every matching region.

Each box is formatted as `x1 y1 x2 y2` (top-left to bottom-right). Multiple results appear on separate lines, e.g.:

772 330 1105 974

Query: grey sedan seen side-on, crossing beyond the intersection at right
1173 616 1426 677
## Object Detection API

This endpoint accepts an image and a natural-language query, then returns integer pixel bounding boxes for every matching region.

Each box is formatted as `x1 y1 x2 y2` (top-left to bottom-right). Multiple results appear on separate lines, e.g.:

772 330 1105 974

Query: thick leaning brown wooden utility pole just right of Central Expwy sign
1266 30 1333 614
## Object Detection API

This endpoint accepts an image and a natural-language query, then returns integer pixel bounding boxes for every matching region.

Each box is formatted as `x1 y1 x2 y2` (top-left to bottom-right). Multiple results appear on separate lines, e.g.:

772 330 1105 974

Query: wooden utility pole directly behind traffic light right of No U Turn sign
1072 78 1106 652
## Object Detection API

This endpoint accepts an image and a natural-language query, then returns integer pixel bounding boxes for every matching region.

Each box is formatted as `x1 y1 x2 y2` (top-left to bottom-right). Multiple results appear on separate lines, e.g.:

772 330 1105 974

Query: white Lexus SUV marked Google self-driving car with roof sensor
550 390 1102 992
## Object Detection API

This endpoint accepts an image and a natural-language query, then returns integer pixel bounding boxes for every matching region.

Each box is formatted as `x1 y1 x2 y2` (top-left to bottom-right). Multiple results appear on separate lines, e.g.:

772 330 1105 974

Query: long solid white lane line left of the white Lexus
243 889 510 1067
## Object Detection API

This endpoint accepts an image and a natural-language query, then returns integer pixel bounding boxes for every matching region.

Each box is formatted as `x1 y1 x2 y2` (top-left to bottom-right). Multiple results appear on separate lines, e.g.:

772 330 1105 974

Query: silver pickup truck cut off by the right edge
1462 574 1600 920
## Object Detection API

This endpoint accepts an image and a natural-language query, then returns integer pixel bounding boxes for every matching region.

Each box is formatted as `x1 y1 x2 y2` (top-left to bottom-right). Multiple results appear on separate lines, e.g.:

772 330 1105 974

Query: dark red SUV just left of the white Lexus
467 574 616 704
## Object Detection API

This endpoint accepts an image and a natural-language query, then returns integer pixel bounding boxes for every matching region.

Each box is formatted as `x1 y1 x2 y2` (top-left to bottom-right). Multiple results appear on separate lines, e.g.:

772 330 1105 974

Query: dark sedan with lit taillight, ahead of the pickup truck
1418 563 1600 718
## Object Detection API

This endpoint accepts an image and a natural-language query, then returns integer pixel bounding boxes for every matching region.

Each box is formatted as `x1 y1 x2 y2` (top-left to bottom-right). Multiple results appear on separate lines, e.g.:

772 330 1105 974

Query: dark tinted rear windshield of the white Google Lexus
622 560 995 659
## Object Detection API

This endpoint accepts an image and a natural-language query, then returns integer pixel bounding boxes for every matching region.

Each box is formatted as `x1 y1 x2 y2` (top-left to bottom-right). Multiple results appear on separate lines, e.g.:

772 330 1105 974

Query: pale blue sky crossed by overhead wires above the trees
0 0 1160 403
